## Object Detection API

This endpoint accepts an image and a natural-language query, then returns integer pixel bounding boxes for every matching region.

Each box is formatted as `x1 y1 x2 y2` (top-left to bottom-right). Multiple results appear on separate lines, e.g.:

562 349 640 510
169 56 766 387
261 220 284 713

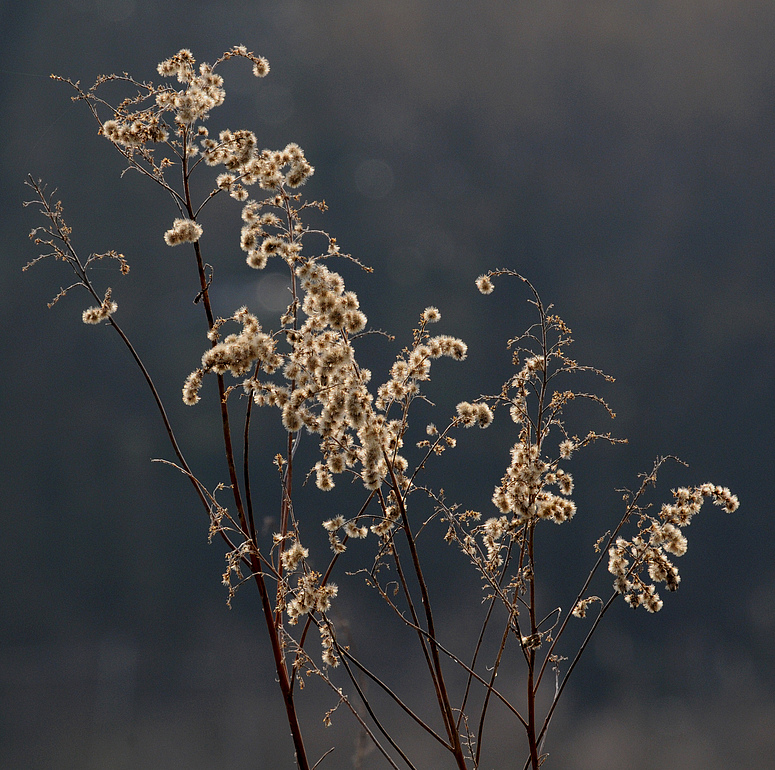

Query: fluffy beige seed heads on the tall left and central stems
89 46 478 622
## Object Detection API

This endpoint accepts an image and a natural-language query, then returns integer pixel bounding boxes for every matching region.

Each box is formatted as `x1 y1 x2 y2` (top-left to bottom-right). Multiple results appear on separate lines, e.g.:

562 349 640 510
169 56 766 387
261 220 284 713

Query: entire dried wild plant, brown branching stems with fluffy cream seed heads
25 46 738 770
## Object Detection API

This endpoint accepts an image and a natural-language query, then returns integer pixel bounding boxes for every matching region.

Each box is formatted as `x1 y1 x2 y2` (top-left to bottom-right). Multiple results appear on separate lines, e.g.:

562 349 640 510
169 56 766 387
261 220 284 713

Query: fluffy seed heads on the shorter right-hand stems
440 270 739 617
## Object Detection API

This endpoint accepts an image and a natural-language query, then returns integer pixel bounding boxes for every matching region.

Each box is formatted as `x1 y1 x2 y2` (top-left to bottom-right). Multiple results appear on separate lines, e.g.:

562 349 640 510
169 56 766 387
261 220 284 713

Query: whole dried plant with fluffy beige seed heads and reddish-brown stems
31 46 738 769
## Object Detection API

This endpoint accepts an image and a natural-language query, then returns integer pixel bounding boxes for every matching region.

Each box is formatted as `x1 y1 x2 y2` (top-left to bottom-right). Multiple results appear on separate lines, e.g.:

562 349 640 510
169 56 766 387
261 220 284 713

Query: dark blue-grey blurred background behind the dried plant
0 0 775 770
